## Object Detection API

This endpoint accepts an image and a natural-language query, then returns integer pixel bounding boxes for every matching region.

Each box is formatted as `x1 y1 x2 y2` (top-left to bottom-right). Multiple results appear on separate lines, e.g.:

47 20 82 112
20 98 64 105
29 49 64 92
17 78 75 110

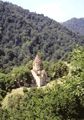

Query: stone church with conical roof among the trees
31 54 50 87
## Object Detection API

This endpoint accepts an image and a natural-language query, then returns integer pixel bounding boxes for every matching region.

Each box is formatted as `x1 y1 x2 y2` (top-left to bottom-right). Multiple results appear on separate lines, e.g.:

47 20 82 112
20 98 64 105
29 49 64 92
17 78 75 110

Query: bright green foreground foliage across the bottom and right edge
0 47 84 120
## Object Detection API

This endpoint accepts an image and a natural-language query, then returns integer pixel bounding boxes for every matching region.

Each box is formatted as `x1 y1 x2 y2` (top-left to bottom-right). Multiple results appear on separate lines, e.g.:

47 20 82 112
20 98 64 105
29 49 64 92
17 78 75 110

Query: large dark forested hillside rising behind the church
0 1 84 72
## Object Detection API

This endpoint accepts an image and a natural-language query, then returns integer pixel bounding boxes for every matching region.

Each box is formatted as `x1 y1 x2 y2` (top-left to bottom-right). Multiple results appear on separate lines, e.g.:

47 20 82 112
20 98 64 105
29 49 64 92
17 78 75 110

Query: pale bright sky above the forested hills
2 0 84 22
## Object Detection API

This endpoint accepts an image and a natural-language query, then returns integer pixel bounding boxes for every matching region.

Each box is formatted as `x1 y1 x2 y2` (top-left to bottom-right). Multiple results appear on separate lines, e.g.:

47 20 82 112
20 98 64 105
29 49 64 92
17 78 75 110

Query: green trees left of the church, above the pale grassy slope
0 66 33 101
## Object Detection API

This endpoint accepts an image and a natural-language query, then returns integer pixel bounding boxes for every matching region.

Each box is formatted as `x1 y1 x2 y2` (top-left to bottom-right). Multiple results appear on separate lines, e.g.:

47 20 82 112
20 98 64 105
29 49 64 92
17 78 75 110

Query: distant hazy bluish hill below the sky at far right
62 18 84 35
